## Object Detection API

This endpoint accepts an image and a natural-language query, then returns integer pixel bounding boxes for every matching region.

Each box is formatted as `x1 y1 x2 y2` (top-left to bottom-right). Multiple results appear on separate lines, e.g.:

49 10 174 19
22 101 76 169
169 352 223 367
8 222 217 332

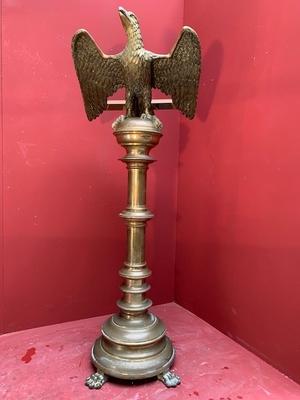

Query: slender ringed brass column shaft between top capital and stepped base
118 157 153 316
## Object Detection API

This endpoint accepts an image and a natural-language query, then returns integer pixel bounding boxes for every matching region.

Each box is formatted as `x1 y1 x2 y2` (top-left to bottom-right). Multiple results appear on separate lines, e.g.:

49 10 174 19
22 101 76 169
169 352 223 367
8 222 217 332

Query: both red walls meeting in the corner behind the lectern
0 0 300 390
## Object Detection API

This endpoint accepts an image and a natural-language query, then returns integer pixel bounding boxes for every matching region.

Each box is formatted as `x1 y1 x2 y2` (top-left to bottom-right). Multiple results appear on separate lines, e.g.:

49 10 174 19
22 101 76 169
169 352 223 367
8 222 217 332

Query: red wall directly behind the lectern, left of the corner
0 0 183 332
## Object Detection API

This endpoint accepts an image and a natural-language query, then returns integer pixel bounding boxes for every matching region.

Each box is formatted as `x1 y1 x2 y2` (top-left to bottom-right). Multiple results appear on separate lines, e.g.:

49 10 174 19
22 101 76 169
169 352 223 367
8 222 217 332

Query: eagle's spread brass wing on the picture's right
152 26 201 119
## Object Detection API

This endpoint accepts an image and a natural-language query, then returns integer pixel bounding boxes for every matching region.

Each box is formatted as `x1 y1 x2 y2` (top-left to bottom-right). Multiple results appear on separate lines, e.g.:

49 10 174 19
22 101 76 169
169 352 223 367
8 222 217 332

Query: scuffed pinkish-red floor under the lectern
0 303 300 400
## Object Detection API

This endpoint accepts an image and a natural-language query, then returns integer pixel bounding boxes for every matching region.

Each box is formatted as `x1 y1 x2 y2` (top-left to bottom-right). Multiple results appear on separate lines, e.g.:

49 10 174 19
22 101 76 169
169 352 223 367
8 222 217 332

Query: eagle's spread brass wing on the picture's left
72 29 124 121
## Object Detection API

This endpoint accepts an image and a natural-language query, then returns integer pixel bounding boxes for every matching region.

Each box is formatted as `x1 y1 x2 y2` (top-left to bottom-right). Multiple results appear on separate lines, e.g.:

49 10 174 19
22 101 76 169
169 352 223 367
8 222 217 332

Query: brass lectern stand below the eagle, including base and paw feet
87 118 179 388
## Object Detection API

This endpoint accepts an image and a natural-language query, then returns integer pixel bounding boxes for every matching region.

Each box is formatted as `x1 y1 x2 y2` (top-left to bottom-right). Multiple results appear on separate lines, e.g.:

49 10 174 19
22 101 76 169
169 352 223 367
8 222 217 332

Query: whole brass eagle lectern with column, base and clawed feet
72 7 200 389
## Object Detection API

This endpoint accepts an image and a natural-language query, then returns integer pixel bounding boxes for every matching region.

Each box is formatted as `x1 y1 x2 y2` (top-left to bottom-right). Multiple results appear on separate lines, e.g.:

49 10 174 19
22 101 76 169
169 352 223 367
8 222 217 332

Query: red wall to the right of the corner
176 0 300 381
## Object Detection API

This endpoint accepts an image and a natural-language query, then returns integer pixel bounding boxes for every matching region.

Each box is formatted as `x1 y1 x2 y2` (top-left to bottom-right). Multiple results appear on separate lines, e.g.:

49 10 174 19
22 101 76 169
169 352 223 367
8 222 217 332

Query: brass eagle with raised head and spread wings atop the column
72 7 201 121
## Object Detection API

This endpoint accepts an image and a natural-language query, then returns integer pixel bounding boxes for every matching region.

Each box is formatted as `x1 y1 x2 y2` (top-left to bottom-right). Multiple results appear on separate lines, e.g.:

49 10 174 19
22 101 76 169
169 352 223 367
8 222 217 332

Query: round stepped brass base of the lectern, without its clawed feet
92 313 175 380
